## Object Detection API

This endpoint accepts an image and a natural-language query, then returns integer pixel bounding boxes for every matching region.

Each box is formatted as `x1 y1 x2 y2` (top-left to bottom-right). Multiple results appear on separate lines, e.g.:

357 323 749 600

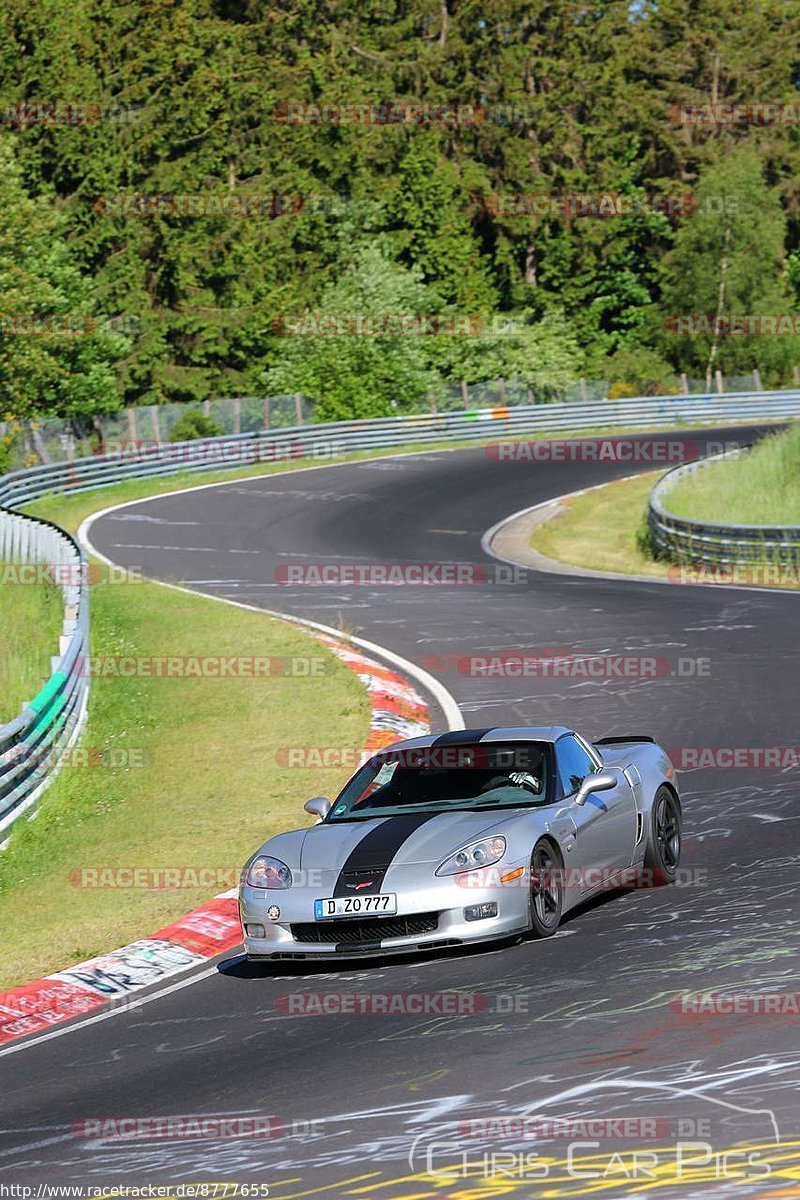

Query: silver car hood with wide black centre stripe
291 809 528 871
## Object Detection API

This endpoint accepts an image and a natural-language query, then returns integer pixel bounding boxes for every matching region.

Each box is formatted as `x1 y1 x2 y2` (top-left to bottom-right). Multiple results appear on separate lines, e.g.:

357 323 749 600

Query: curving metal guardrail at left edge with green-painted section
0 509 89 833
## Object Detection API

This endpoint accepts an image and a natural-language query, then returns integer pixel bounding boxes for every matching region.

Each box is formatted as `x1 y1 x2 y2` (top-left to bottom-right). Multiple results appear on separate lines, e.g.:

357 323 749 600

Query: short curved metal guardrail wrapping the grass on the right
648 448 800 566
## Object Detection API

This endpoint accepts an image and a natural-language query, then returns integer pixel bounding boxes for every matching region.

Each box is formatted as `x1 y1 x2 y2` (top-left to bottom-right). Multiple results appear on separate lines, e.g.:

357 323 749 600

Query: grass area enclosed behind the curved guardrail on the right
663 424 800 526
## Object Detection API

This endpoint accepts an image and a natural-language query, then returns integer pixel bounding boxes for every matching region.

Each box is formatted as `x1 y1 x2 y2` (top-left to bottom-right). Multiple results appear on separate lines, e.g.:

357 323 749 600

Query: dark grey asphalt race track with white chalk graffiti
0 430 800 1200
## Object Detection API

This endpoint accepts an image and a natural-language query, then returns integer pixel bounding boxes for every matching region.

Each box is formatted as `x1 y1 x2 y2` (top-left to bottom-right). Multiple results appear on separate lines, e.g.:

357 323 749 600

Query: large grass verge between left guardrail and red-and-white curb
0 501 369 988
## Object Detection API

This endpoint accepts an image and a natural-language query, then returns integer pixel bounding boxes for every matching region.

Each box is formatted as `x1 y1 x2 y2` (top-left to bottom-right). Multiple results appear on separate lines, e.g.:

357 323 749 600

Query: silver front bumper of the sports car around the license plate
239 864 529 959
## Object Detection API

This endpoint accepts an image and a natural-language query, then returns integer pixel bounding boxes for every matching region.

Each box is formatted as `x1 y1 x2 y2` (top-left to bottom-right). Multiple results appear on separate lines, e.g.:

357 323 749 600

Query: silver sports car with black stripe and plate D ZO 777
240 725 681 959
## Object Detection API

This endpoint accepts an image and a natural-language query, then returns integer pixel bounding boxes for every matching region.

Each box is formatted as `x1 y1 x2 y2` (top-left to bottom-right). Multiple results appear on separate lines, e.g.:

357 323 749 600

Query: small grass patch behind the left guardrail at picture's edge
0 563 64 725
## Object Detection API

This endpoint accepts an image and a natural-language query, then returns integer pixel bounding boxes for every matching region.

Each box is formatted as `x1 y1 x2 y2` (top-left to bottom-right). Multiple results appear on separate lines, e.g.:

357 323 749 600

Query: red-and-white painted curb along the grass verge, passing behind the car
0 634 431 1044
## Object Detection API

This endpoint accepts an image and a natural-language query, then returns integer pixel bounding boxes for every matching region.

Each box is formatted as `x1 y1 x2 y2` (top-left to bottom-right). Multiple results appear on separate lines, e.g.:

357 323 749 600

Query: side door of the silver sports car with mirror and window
555 733 636 892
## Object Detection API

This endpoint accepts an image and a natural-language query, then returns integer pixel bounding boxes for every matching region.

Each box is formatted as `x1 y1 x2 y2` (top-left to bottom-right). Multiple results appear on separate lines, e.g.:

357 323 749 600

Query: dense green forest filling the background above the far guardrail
0 0 800 419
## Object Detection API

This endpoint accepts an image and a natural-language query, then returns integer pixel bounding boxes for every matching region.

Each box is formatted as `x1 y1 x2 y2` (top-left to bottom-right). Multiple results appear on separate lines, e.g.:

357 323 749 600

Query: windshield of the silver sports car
326 742 552 822
